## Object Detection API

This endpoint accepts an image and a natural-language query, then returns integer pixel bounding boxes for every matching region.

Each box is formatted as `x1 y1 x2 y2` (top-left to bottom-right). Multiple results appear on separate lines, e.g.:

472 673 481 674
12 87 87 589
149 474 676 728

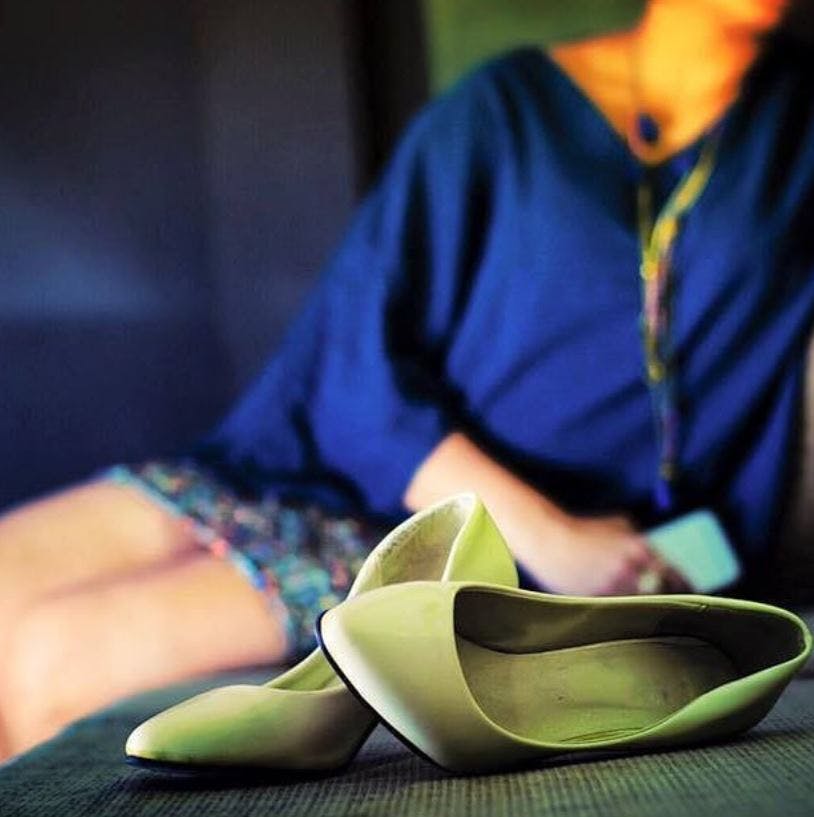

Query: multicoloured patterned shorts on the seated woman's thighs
98 460 386 657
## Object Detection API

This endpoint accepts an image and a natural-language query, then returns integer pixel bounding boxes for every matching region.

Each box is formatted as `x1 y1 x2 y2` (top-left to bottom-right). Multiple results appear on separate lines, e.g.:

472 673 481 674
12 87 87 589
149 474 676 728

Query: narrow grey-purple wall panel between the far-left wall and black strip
199 0 357 388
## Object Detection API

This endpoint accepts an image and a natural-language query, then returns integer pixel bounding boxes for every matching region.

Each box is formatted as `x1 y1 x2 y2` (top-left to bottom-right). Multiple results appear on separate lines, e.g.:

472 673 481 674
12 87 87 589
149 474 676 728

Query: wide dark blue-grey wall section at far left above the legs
0 0 223 503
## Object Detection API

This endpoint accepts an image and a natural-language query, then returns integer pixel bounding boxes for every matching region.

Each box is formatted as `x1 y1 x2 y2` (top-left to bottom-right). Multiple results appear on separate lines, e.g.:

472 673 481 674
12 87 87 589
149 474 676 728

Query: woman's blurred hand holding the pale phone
516 504 690 596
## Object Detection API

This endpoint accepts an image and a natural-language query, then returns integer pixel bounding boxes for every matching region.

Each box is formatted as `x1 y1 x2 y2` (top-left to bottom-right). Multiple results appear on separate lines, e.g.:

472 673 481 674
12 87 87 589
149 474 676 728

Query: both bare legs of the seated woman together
0 481 290 759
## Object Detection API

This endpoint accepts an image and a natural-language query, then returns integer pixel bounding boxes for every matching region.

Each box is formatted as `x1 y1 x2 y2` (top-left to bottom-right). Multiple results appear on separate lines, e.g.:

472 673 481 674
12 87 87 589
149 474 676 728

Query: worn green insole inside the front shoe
457 636 738 743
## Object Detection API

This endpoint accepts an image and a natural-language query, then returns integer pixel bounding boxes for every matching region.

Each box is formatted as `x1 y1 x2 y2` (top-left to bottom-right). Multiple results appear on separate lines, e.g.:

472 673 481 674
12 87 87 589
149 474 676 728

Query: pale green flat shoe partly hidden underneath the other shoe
125 494 517 773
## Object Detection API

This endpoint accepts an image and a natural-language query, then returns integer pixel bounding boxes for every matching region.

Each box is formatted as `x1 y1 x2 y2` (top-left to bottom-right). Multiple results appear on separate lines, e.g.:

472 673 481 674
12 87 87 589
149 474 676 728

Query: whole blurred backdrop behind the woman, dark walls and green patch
0 0 812 508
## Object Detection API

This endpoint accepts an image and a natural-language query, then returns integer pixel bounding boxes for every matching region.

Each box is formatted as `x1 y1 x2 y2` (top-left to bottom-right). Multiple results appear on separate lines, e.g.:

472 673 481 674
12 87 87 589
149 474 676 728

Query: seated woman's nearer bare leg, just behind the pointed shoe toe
0 552 286 753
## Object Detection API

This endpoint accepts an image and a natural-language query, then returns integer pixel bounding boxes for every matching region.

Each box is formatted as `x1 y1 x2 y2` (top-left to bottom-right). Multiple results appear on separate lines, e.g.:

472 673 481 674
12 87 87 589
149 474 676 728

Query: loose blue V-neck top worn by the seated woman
194 36 814 565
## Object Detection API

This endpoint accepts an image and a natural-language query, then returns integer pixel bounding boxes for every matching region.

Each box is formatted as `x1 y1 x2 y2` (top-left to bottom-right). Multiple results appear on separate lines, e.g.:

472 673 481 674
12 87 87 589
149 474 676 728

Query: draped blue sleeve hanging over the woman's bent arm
192 68 504 517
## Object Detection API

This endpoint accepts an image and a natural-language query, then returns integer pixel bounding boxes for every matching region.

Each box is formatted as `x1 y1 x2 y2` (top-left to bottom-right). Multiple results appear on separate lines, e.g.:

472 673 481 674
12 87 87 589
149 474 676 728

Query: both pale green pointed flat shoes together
126 495 812 772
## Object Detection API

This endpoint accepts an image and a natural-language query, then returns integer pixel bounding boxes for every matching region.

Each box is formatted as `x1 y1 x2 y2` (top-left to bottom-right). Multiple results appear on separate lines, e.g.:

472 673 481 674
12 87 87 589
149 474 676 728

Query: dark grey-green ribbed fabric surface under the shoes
0 648 814 817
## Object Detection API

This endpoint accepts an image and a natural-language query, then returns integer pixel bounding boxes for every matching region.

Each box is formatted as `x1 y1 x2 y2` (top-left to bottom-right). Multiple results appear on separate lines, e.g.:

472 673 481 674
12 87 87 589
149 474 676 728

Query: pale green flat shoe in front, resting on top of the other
317 582 811 772
